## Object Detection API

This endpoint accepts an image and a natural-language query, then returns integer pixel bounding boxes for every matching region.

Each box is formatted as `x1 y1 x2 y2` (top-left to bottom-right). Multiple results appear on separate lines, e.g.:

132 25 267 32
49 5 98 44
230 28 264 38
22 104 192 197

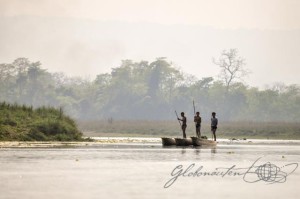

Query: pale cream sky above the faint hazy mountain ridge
0 0 300 30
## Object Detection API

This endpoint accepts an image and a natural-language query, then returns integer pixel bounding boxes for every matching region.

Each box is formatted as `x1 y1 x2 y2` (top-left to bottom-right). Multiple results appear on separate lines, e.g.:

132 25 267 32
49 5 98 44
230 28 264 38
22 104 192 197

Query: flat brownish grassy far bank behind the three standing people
78 120 300 139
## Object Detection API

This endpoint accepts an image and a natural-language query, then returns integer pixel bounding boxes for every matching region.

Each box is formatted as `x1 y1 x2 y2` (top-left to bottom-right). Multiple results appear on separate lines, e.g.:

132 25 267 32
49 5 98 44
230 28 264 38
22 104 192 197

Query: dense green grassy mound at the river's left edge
0 102 82 141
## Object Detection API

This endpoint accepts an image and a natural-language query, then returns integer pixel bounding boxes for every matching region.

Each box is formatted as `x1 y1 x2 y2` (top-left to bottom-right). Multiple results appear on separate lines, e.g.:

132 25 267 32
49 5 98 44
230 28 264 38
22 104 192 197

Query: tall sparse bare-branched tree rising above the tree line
213 49 250 91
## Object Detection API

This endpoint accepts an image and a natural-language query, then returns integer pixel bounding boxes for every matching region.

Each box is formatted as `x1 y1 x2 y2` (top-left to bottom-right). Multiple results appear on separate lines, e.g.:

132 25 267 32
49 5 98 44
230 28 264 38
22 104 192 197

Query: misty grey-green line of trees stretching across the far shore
0 52 300 122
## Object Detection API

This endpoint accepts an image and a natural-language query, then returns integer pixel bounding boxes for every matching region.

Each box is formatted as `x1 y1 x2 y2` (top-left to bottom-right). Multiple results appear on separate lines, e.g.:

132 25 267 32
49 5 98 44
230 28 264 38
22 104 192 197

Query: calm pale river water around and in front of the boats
0 141 300 199
